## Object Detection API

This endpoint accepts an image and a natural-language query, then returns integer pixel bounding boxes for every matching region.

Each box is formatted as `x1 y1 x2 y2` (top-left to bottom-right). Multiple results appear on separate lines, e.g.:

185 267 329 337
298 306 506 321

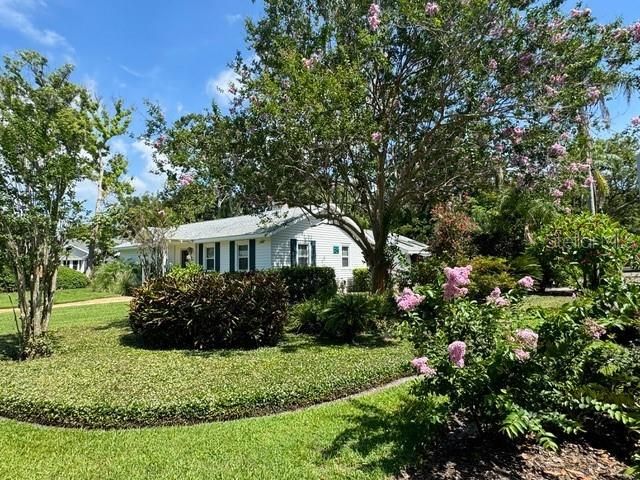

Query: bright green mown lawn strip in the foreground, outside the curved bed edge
0 386 418 480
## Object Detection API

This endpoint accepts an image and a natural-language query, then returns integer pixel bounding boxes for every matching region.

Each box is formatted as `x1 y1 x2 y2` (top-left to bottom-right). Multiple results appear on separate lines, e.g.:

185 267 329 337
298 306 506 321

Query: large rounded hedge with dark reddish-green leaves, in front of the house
129 272 287 350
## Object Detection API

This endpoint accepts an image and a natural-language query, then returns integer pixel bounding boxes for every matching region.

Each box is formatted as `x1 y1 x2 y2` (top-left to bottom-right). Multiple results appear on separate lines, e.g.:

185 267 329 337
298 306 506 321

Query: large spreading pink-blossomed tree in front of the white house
222 0 640 290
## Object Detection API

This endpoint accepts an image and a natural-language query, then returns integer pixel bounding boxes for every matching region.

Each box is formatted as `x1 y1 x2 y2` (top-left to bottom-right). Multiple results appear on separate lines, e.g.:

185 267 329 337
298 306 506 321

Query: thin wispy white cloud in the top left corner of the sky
0 0 73 50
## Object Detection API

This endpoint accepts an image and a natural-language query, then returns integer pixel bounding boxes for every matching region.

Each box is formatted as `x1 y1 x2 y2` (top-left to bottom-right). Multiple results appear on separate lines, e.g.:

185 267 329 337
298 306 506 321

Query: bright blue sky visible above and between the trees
0 0 640 210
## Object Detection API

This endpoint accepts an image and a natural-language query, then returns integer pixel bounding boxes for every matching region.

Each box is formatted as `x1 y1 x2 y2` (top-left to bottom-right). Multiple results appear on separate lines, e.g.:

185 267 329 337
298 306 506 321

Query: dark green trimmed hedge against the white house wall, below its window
275 267 338 303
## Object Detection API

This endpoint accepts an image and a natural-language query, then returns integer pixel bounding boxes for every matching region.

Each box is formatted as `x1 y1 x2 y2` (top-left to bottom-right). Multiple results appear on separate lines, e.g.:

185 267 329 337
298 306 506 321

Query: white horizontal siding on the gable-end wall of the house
271 219 366 283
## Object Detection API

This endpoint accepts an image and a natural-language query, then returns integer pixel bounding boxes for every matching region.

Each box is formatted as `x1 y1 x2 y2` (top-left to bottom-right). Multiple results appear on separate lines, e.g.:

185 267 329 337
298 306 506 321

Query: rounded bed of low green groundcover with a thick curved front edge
0 304 412 428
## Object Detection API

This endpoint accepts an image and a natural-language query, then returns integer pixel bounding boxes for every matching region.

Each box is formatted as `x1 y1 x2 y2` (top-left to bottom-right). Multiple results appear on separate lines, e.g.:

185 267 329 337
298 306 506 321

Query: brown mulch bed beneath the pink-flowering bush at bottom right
396 441 630 480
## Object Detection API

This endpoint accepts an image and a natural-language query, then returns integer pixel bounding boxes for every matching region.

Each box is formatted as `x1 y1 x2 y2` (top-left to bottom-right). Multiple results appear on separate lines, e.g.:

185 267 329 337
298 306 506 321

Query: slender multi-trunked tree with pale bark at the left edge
0 52 94 358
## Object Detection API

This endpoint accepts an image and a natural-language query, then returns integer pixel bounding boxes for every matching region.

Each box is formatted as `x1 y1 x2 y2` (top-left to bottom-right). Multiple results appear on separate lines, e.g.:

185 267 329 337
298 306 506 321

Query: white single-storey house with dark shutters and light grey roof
115 208 426 285
